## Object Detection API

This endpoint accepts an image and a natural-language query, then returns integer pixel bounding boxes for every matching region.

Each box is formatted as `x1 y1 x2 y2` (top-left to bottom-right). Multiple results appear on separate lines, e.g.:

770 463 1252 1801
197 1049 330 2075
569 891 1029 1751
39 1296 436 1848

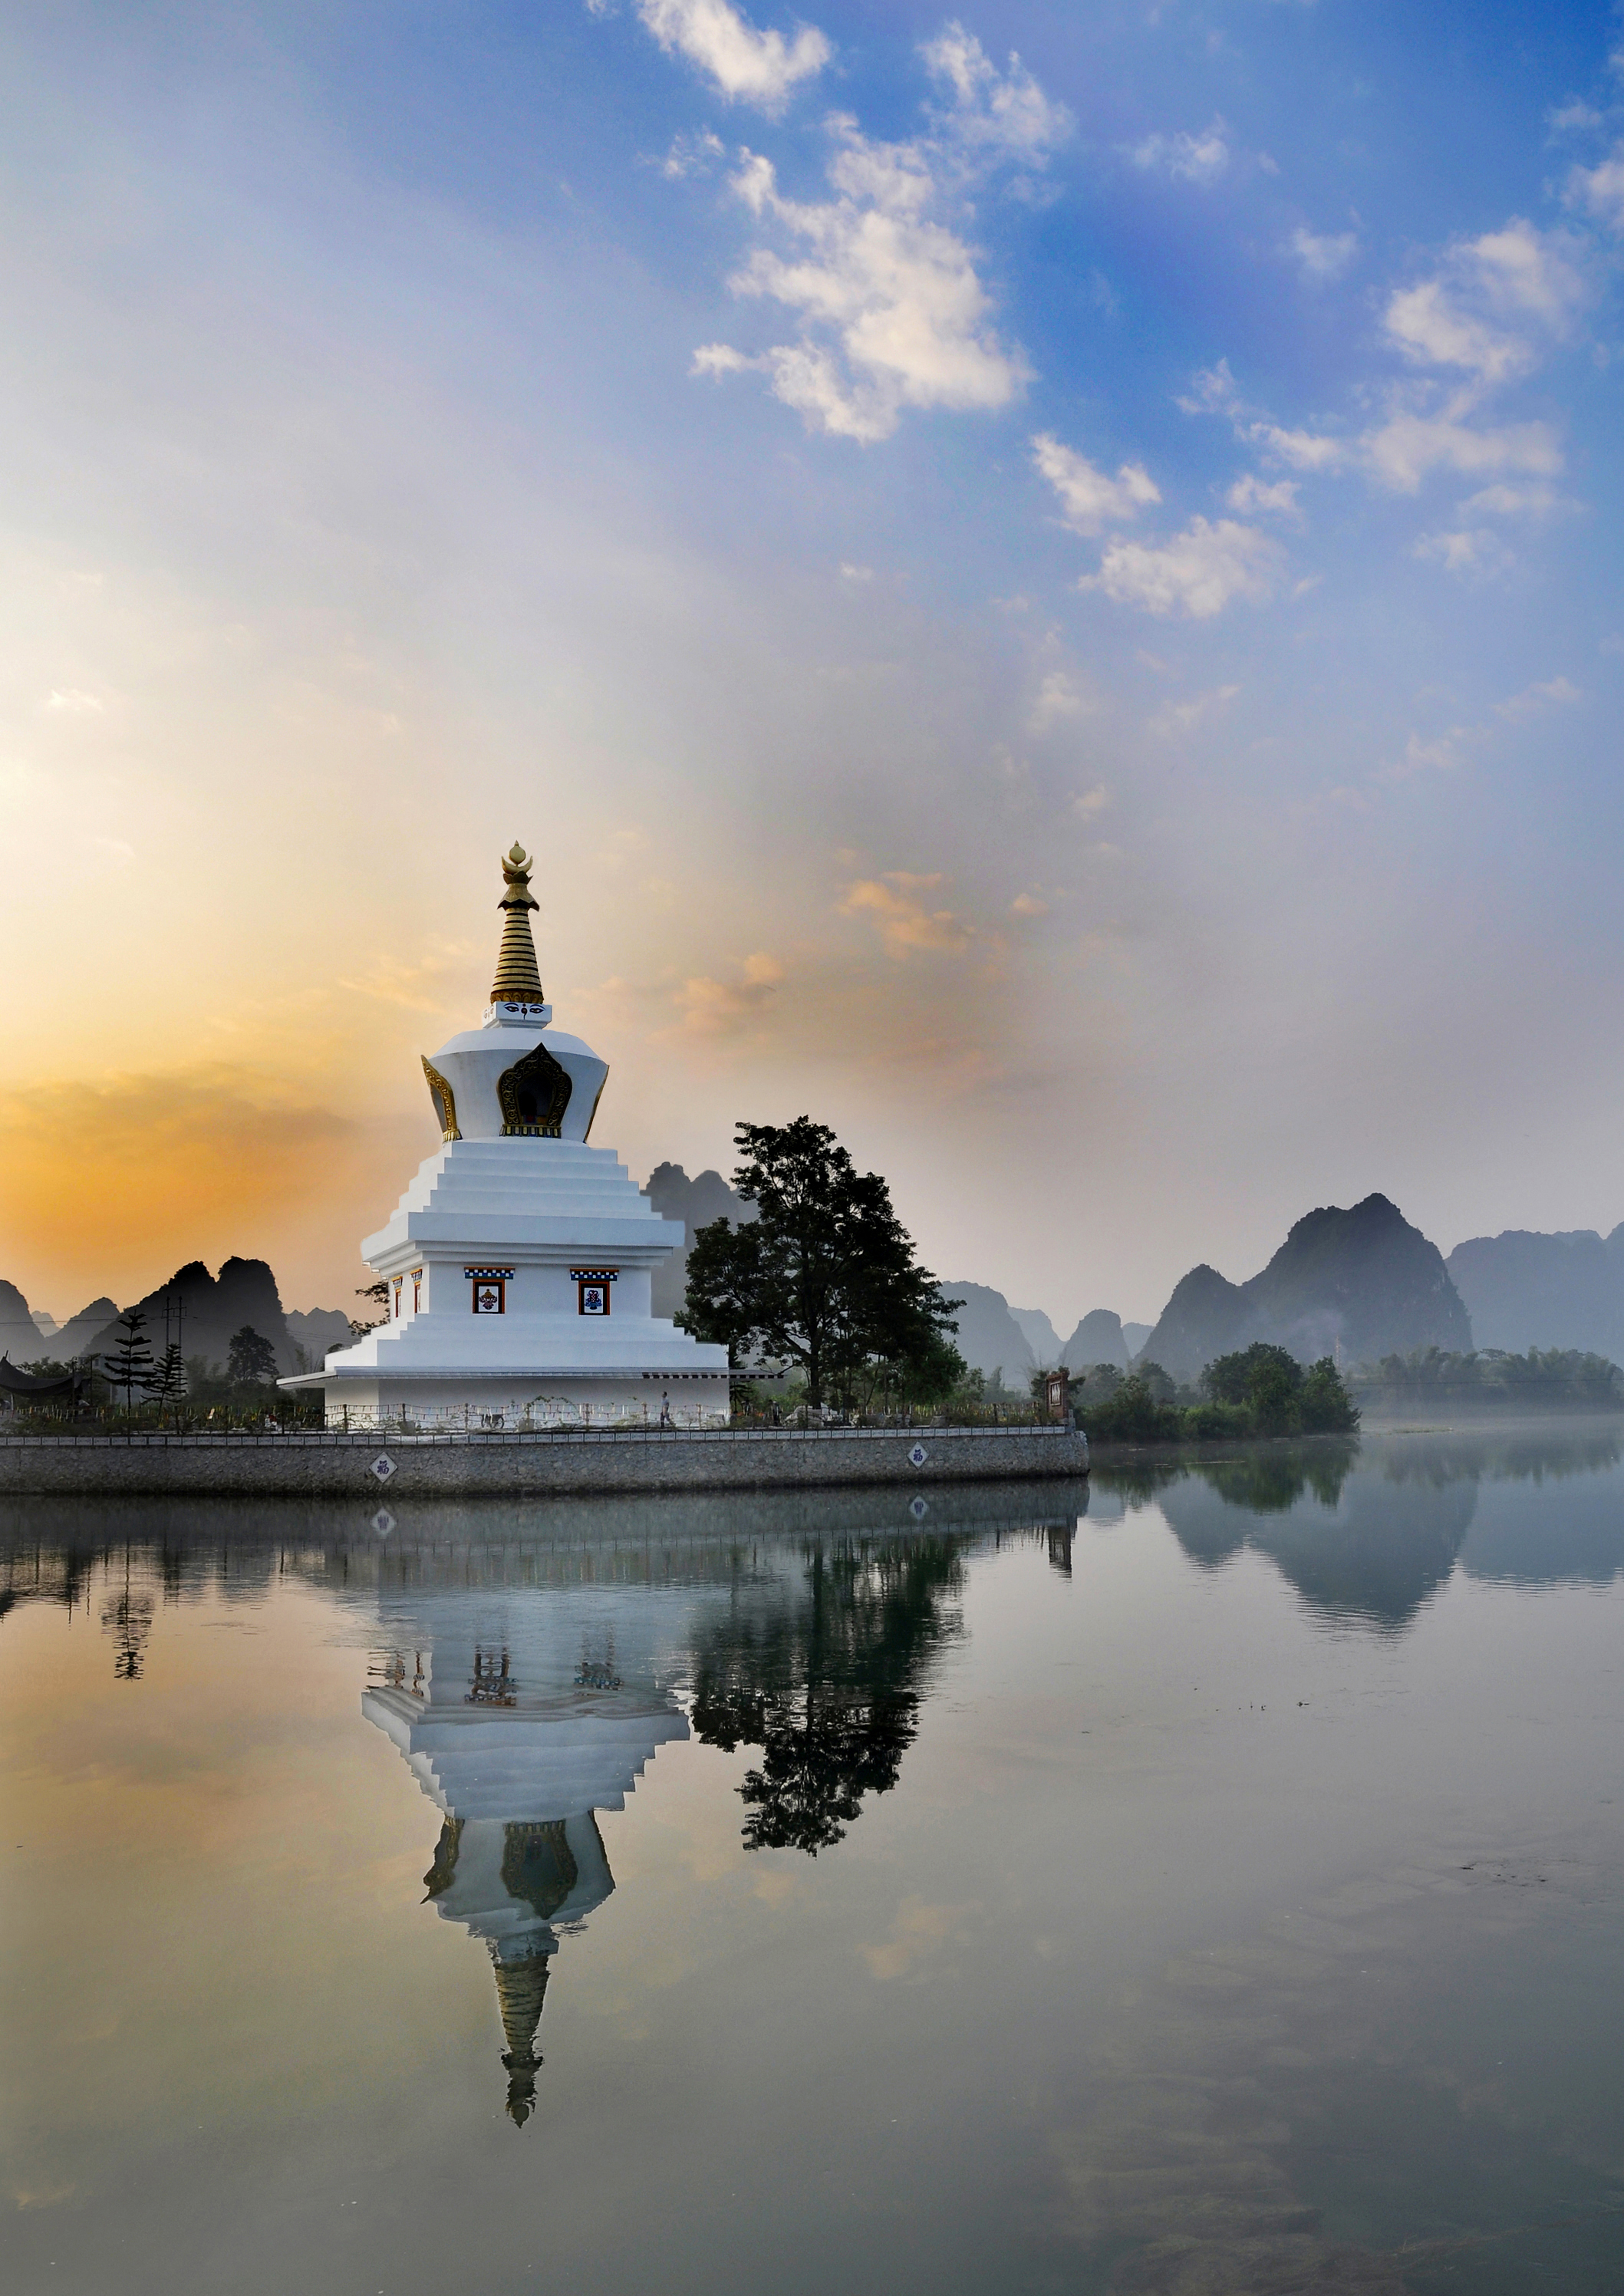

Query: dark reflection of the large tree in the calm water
691 1536 965 1857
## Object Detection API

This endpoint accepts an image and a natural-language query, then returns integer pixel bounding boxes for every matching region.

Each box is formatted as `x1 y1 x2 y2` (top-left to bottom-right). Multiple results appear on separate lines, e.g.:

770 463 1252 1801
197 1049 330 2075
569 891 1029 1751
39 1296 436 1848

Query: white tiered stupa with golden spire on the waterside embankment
280 845 728 1428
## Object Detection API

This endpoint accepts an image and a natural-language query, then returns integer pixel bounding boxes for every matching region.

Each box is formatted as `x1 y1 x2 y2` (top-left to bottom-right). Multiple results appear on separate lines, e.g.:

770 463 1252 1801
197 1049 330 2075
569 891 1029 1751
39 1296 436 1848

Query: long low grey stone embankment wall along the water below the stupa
0 1428 1089 1499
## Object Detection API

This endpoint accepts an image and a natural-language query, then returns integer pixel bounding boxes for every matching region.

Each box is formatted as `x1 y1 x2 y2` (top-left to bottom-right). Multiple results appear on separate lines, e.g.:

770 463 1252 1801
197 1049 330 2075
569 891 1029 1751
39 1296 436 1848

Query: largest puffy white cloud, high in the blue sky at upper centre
693 120 1029 443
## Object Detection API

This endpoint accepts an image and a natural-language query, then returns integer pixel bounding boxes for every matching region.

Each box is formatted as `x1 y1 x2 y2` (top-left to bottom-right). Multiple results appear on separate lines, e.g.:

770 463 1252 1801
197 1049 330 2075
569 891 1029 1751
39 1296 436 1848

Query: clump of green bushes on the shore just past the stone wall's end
1075 1341 1360 1444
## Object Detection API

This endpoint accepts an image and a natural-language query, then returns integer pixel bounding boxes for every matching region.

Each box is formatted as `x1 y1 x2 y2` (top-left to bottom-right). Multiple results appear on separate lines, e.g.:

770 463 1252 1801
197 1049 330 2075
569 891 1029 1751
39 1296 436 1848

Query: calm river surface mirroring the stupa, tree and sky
0 1428 1624 2296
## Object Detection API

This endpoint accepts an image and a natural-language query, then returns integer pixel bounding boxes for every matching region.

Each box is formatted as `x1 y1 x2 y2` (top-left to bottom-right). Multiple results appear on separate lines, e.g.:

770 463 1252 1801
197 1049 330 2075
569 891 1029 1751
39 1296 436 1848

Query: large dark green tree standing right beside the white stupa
677 1116 963 1403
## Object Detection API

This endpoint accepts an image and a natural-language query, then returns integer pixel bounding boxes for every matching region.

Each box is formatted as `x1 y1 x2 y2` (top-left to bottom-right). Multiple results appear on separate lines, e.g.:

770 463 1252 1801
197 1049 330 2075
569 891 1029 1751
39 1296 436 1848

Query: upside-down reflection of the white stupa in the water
361 1593 689 2129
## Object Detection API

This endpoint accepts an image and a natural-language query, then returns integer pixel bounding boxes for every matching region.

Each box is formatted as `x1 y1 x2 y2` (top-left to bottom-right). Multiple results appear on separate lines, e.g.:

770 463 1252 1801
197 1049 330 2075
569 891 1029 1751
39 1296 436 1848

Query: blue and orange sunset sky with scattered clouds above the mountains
0 0 1624 1336
